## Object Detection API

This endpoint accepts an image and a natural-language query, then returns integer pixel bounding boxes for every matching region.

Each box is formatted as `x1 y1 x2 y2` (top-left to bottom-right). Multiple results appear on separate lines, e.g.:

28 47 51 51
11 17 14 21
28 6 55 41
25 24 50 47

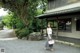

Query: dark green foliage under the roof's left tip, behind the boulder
32 18 47 32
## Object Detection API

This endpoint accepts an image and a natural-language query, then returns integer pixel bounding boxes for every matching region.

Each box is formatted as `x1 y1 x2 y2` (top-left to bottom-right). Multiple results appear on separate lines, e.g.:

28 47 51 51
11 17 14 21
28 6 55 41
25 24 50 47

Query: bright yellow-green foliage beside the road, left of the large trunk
2 13 25 29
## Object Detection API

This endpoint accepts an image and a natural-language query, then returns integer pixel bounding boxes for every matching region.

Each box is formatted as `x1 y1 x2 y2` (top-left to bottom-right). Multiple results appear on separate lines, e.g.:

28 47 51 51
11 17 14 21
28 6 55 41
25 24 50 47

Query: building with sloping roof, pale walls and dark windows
37 0 80 44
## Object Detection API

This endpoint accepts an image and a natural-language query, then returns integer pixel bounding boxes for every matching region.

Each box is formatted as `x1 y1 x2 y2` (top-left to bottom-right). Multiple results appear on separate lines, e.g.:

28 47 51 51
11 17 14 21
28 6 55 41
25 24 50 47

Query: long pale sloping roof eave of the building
36 2 80 18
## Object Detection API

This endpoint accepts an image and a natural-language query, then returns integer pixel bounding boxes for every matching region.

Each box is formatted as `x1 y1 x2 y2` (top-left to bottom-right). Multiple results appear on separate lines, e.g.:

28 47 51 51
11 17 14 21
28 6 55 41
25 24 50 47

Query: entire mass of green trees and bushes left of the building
0 0 47 38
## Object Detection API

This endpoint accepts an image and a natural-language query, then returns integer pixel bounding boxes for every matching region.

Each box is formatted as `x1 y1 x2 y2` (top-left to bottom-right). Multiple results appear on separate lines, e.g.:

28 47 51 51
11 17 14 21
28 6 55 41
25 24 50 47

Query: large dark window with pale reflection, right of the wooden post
58 18 71 31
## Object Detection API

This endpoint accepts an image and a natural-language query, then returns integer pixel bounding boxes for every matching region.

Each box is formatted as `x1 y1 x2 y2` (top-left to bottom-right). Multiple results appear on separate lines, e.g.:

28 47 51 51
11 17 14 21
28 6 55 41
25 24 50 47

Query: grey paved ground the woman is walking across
0 30 80 53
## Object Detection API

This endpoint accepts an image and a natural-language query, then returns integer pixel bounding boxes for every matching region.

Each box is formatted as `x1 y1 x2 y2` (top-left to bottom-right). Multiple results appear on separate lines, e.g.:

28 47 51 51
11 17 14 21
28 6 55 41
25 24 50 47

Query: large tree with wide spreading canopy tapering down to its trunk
0 0 47 39
